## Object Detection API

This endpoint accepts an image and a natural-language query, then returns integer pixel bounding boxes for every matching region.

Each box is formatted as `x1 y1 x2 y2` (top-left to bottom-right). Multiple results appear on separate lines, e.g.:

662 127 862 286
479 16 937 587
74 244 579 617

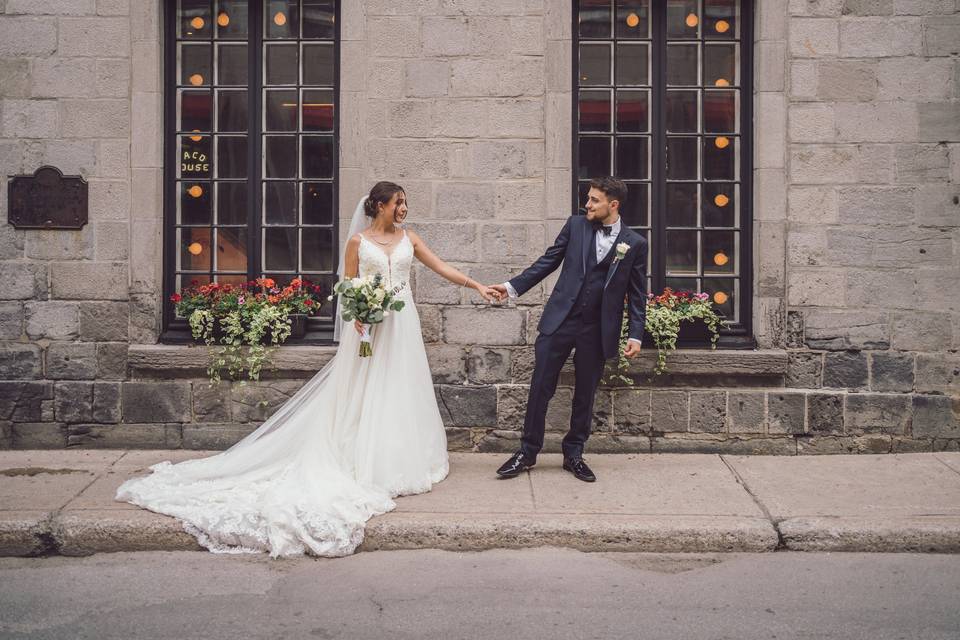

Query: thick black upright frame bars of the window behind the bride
159 0 342 345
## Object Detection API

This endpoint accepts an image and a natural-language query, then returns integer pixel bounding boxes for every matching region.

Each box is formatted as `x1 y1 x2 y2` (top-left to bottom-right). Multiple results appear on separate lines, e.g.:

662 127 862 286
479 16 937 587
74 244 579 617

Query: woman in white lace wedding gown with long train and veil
116 182 497 557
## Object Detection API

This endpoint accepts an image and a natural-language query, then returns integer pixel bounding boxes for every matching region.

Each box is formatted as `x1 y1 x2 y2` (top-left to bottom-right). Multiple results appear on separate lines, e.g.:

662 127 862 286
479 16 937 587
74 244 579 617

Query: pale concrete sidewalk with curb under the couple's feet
0 450 960 556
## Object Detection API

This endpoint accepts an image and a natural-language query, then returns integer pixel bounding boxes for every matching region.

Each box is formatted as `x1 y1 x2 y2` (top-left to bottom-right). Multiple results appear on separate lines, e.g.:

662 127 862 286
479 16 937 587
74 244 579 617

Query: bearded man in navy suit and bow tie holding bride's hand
493 177 647 482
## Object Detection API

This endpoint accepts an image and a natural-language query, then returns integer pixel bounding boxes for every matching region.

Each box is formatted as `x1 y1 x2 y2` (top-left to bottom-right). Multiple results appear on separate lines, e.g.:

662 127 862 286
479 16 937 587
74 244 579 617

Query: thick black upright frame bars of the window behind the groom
570 0 756 349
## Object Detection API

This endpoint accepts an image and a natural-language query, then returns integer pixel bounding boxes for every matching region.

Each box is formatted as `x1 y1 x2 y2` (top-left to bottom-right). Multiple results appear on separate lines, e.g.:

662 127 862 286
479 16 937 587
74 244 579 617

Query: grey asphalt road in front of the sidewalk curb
0 549 960 640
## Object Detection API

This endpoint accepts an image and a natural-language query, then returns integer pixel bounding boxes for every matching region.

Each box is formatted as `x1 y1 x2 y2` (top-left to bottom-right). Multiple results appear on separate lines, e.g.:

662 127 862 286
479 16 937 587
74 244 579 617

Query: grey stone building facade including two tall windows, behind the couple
0 0 960 454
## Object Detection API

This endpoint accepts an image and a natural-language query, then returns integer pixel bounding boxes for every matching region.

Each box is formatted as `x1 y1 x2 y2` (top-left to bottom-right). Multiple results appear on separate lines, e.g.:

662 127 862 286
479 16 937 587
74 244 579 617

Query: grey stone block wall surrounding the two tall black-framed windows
0 0 960 454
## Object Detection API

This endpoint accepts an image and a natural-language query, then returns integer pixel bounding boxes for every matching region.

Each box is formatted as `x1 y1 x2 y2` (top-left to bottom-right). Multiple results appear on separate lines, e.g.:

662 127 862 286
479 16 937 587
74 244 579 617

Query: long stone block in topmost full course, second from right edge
839 17 922 58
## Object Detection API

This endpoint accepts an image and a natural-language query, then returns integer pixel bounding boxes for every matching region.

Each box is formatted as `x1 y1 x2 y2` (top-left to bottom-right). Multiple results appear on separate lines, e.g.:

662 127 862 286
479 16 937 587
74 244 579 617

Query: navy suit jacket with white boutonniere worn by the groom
510 215 647 358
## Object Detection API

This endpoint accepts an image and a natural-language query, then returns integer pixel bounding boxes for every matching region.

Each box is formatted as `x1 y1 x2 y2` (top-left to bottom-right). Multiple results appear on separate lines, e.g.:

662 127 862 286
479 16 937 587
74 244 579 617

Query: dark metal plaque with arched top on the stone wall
7 166 88 229
